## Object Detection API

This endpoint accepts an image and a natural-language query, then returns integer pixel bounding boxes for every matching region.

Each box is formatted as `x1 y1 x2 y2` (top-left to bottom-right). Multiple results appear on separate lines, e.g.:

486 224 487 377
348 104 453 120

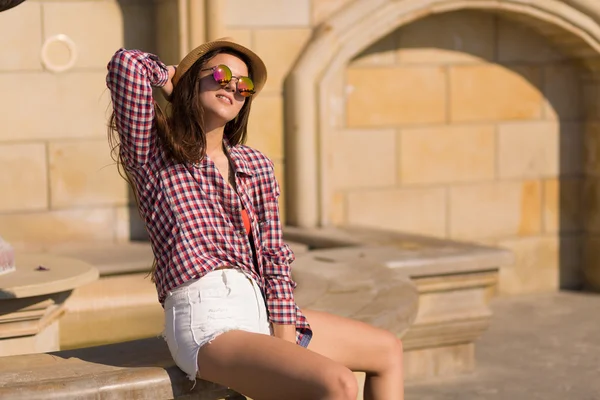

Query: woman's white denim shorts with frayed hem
163 269 272 380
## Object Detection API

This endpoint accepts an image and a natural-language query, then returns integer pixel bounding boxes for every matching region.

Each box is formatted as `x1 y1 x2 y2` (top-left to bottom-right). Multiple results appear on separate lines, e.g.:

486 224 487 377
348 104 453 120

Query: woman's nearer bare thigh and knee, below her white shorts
198 331 358 400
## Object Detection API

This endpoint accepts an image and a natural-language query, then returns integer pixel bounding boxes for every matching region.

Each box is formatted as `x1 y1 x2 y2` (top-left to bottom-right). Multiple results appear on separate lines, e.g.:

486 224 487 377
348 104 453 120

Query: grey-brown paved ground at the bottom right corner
406 292 600 400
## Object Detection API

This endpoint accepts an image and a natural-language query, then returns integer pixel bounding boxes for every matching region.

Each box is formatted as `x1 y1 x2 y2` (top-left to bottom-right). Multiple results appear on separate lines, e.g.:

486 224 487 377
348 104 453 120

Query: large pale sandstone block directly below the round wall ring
0 72 110 142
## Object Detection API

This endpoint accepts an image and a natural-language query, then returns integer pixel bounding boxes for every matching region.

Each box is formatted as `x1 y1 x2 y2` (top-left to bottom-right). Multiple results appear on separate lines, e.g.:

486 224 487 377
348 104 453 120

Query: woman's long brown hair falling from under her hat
108 48 253 282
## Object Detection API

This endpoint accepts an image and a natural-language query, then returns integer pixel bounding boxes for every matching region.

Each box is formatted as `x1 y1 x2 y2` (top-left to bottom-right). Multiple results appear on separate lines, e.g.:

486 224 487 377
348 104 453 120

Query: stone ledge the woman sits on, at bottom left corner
0 338 245 400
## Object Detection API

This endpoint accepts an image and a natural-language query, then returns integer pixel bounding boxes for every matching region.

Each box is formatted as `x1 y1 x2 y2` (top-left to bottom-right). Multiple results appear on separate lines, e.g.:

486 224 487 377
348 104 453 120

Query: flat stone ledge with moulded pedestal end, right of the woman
287 228 513 380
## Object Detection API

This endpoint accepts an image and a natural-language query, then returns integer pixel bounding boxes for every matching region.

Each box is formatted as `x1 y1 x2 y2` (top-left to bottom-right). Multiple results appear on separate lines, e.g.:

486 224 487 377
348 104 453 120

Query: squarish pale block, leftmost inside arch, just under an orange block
328 129 396 189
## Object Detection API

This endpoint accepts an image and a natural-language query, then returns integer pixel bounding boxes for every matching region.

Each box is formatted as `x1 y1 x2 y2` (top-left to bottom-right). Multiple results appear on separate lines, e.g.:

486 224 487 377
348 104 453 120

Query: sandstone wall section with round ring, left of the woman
0 0 129 246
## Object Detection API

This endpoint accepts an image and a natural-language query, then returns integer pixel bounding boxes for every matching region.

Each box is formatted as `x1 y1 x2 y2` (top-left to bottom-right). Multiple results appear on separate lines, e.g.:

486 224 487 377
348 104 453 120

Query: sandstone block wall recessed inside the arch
326 11 586 293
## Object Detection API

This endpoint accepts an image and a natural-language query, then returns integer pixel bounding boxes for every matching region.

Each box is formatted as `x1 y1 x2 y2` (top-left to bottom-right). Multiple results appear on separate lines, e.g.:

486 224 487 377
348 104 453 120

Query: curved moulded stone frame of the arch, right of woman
285 0 600 228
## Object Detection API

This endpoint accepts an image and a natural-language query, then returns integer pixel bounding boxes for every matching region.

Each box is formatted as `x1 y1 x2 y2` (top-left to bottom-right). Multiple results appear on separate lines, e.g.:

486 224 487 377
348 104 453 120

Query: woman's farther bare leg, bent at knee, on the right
303 310 404 400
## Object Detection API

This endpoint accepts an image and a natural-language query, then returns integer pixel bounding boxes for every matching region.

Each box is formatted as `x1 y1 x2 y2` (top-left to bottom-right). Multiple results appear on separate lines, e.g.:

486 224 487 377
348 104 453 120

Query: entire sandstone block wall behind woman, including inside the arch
0 0 600 293
